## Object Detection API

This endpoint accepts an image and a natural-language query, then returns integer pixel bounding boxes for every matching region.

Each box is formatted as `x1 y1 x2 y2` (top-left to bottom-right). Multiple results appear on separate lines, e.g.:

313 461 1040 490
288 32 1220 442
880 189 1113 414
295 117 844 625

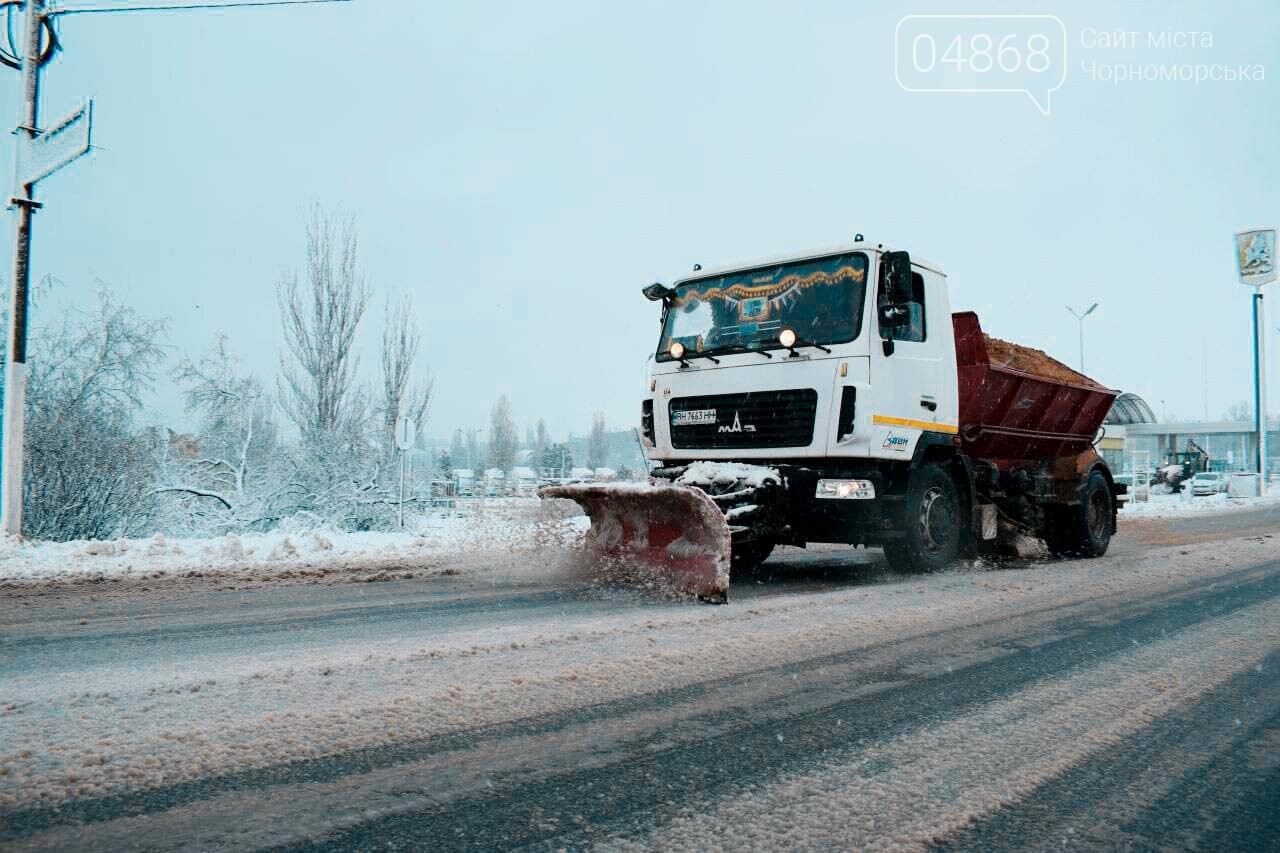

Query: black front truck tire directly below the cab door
884 462 964 573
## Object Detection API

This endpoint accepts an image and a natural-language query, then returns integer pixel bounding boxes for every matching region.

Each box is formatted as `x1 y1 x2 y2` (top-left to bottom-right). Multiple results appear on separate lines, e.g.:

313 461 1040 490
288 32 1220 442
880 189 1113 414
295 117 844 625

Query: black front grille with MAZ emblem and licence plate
668 388 818 450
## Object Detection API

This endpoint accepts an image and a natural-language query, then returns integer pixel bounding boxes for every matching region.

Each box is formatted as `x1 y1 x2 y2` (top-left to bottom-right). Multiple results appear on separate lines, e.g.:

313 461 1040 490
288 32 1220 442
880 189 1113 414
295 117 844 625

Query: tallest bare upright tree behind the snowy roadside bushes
276 206 369 439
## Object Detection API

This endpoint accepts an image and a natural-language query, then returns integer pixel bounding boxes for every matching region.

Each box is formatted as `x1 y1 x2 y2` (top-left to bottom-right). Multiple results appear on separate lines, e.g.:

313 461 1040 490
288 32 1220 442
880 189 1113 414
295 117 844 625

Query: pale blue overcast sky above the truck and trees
10 0 1280 435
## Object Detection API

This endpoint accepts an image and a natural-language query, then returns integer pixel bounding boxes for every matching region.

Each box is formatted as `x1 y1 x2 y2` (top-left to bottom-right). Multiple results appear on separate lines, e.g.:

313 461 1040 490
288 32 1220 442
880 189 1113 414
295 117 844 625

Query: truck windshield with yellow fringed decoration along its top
657 252 867 361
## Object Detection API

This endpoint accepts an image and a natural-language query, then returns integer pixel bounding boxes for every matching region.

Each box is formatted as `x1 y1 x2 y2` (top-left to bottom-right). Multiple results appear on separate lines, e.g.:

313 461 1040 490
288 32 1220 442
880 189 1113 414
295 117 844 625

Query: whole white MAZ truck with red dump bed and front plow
541 236 1124 602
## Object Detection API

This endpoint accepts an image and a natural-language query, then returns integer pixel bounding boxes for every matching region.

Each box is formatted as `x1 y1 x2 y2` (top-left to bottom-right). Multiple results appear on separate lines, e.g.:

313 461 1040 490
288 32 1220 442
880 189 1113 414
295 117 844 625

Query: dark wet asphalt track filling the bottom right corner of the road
938 653 1280 852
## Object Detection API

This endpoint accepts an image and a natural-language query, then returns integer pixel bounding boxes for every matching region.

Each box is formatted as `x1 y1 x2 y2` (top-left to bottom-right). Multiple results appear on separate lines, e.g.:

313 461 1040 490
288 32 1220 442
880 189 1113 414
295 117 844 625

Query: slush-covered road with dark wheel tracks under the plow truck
0 514 1280 850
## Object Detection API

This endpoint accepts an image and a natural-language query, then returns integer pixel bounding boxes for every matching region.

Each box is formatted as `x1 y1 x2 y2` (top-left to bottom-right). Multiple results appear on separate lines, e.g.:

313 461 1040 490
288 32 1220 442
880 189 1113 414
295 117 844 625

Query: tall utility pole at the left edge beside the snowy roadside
0 0 45 535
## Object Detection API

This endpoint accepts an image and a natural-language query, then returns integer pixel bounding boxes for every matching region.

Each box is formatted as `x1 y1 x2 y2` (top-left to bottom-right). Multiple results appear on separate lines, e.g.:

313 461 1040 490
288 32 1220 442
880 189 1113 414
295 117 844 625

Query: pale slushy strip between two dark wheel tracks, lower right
604 601 1280 850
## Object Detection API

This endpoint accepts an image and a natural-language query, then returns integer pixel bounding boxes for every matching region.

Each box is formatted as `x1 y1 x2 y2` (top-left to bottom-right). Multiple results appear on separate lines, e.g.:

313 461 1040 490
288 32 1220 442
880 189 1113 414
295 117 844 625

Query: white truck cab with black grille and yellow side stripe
644 241 959 464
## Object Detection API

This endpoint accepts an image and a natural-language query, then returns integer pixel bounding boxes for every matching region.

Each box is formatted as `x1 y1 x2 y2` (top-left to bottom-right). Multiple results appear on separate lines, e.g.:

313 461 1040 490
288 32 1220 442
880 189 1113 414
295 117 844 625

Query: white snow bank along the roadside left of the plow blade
0 500 589 585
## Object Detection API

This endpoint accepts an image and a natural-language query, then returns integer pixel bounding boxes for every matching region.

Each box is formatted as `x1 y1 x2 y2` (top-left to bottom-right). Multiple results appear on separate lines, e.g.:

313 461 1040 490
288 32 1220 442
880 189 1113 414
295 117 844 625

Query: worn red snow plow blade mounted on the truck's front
538 482 730 603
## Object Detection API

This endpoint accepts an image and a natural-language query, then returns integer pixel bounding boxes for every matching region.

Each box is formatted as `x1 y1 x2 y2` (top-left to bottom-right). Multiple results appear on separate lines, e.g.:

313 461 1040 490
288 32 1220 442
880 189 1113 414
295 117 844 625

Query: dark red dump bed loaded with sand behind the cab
951 311 1120 460
